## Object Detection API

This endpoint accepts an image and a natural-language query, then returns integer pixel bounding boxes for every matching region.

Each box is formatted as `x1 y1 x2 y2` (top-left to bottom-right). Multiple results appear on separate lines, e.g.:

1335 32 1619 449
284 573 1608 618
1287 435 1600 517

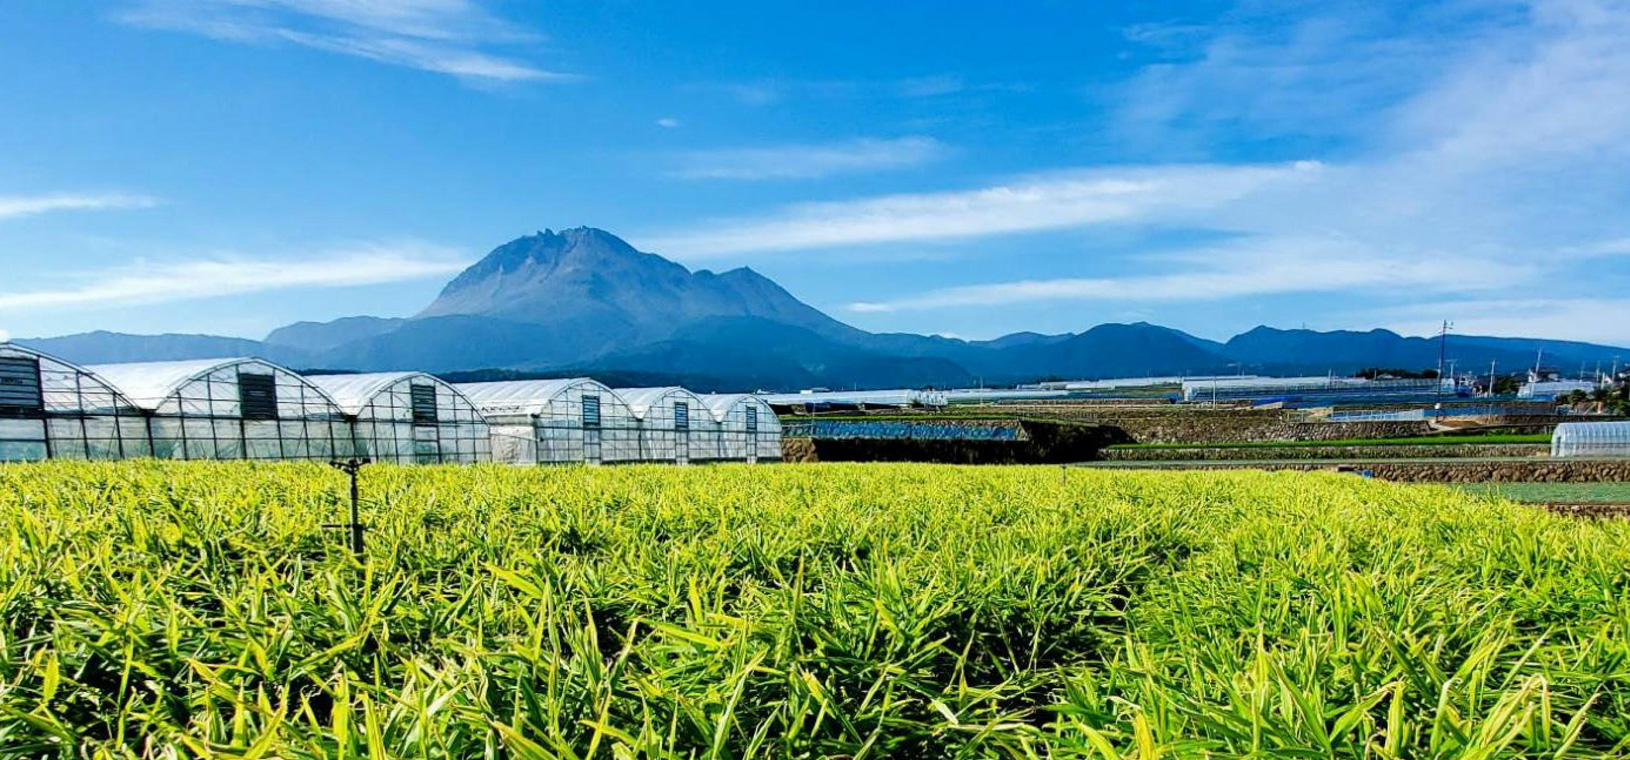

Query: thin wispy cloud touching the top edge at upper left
114 0 575 82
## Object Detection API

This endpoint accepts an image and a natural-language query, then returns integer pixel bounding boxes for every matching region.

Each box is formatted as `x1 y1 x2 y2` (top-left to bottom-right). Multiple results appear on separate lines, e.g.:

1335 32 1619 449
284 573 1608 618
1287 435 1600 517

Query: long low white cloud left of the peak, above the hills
0 243 468 312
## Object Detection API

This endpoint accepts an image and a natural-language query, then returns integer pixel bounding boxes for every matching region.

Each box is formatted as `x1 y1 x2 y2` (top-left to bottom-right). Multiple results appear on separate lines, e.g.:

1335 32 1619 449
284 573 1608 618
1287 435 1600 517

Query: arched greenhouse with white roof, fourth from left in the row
458 377 641 465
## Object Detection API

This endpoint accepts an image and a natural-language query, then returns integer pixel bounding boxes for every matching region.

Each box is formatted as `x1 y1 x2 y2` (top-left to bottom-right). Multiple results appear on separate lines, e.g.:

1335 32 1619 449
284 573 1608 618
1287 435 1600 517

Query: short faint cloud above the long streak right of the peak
673 137 947 179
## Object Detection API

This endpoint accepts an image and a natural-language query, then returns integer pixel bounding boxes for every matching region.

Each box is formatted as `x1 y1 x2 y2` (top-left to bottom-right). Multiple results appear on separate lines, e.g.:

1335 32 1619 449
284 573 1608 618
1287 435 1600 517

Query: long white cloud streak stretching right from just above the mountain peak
644 161 1320 259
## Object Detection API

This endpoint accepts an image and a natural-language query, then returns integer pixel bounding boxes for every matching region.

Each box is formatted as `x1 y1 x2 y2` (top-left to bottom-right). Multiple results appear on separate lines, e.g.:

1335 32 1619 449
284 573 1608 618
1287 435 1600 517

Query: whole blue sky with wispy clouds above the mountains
0 0 1630 346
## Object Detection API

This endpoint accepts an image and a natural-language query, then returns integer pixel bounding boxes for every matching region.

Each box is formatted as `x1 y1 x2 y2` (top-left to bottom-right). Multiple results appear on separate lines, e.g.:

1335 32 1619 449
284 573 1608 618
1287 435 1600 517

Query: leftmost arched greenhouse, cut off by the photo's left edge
0 342 152 462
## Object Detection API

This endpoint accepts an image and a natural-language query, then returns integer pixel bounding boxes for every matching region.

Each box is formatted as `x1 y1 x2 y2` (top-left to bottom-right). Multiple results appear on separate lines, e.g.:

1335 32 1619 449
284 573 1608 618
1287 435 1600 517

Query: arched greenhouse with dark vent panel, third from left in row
306 372 492 465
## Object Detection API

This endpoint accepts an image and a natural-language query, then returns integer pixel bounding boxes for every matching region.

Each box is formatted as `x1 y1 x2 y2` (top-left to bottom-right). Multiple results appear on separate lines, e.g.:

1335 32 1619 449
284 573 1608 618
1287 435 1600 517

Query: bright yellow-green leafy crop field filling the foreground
0 463 1630 760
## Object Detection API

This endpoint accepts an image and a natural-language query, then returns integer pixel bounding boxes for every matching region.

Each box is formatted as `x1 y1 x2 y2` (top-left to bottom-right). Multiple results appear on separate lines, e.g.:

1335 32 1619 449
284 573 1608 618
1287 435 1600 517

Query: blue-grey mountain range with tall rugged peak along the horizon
18 227 1630 390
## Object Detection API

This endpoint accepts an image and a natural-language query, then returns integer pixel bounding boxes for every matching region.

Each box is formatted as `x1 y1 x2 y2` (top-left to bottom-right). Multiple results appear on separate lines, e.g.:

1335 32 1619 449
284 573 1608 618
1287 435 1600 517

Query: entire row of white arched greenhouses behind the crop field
0 342 781 465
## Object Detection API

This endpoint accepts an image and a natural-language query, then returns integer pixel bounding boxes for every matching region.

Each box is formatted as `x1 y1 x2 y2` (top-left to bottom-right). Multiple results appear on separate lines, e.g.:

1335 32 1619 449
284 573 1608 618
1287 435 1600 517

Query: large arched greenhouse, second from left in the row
86 359 354 462
